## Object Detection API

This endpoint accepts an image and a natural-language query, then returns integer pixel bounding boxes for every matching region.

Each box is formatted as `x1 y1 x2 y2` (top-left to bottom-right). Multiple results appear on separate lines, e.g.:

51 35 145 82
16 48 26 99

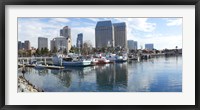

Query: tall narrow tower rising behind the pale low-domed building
60 26 72 52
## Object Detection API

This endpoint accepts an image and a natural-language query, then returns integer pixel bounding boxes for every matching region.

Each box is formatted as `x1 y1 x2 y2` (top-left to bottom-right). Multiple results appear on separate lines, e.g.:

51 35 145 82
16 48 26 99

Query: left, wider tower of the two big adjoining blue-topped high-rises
95 21 114 48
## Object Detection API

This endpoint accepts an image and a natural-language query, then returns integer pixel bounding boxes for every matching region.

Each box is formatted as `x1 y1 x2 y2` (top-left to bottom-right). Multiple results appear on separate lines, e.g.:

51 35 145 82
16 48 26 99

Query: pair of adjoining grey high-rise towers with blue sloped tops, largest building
95 20 127 48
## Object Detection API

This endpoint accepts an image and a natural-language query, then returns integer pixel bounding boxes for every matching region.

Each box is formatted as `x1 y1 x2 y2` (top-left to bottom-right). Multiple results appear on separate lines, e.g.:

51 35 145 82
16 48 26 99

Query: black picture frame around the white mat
0 0 200 110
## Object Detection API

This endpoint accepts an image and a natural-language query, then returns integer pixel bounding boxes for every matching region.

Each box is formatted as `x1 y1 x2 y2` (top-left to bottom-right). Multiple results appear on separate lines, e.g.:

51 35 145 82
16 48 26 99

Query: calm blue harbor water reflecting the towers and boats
18 56 182 92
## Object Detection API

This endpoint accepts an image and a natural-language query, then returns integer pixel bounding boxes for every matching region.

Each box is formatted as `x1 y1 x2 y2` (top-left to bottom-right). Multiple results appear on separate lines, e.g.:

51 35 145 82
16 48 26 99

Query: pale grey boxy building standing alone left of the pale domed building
38 37 48 50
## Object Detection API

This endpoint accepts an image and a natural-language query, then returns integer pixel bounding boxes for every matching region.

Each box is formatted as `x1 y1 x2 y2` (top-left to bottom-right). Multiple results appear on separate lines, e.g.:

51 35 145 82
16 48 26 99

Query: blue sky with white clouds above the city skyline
18 17 182 49
